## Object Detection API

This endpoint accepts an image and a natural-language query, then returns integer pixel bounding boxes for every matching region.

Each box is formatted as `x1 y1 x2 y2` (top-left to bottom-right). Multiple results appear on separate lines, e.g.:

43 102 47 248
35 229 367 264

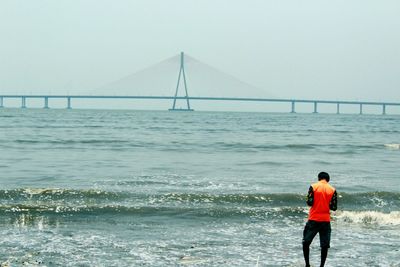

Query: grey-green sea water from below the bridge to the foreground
0 109 400 266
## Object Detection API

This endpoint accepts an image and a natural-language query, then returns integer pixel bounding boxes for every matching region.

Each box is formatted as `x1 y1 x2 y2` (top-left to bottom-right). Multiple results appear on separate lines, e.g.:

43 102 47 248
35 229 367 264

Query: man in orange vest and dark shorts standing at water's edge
303 172 337 267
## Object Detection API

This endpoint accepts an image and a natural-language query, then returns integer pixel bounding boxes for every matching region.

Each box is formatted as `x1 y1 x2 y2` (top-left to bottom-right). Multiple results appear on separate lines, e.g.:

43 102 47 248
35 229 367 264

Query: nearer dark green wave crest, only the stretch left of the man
0 203 307 220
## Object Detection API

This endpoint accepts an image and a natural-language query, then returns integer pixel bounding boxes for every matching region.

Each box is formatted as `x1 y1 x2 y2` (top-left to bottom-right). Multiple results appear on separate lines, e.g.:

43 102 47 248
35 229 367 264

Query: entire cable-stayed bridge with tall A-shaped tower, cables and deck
0 52 400 115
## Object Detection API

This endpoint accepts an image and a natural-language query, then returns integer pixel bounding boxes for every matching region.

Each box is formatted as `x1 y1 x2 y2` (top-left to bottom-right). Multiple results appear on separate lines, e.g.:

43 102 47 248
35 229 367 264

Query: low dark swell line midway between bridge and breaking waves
7 137 386 155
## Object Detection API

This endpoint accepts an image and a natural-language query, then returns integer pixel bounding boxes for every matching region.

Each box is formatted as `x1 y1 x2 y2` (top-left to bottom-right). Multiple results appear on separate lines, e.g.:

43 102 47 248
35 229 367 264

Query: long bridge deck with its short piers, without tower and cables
0 94 400 115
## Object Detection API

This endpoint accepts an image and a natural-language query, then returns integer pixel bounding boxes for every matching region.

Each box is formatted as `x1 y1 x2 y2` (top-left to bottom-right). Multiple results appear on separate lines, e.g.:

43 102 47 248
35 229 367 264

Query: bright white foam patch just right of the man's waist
333 211 400 225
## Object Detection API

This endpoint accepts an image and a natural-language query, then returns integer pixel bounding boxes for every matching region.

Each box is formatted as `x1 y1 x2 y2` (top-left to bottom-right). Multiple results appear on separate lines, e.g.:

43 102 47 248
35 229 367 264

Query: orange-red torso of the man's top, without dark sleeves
308 180 335 222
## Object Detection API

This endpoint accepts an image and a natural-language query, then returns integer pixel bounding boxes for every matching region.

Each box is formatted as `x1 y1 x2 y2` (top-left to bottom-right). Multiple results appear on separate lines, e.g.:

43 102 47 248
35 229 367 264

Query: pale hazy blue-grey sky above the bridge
0 0 400 101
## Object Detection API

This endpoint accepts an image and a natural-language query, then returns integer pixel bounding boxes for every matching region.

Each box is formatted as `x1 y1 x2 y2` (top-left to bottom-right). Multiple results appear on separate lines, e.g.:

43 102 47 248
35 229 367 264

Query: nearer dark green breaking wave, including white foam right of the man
0 204 400 226
